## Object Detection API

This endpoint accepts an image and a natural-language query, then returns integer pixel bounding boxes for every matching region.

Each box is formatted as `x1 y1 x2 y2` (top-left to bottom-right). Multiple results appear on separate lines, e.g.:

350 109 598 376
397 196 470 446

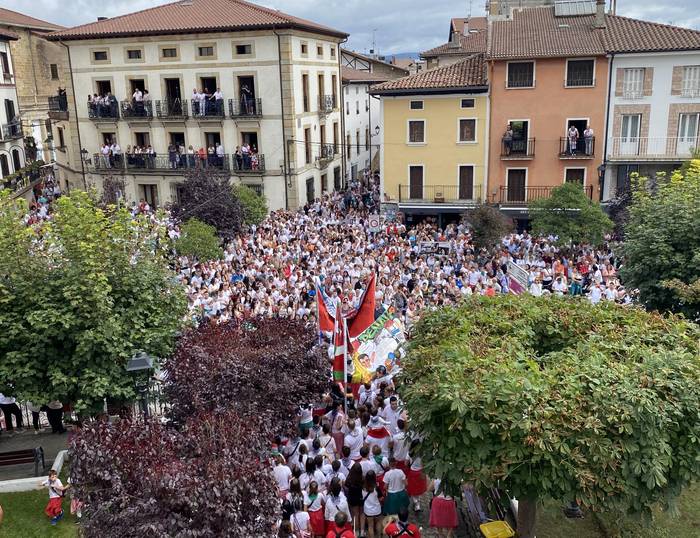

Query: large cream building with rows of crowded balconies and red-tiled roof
50 0 347 210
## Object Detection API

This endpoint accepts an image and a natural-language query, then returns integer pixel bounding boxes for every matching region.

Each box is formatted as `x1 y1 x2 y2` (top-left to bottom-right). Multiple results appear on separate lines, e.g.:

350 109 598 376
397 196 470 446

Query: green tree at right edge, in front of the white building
620 159 700 320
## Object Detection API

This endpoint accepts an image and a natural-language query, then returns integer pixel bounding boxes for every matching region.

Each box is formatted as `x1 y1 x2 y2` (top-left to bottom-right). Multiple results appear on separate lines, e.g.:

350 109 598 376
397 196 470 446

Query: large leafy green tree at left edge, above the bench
0 192 186 410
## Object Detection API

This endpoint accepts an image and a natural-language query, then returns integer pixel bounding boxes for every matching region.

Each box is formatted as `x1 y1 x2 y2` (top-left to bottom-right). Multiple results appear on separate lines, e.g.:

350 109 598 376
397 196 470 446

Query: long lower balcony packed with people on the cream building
92 152 230 175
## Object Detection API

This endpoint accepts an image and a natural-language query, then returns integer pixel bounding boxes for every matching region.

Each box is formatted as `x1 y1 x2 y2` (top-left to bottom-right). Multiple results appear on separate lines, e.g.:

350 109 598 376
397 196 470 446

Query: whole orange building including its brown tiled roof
486 2 608 224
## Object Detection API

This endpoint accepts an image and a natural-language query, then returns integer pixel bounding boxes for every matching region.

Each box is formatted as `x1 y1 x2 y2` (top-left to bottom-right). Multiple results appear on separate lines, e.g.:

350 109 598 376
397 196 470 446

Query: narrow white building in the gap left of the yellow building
342 67 387 180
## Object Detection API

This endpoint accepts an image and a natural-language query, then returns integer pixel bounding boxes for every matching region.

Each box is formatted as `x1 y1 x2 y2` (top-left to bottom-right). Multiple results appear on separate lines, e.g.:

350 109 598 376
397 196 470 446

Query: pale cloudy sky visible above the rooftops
5 0 700 54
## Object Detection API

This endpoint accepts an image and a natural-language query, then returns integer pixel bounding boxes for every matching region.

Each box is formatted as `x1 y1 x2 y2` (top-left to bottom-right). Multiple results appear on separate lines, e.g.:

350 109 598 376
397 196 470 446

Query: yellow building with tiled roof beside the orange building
371 54 489 221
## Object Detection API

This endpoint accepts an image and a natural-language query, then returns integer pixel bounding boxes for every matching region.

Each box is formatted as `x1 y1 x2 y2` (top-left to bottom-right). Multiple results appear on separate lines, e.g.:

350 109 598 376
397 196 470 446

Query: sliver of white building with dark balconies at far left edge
0 30 25 187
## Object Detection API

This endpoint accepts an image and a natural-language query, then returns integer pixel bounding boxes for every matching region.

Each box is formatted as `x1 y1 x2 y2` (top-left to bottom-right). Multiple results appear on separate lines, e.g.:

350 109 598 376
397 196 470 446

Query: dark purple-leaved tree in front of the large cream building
173 168 245 238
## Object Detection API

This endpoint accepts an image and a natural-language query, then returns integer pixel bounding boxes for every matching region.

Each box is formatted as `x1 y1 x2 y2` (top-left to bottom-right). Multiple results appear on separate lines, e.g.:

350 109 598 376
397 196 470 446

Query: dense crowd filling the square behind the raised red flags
177 177 632 327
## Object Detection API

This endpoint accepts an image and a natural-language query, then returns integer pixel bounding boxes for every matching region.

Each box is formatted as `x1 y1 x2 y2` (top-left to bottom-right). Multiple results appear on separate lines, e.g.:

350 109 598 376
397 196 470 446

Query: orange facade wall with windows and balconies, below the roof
488 55 608 208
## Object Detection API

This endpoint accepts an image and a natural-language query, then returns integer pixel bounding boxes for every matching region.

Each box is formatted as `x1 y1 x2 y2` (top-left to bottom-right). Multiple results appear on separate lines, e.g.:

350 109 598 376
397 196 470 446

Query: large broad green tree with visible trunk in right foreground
399 296 700 538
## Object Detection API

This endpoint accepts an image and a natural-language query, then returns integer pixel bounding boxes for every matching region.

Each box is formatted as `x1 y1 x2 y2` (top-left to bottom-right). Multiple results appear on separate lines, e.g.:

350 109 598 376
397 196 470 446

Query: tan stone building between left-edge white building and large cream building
0 8 84 189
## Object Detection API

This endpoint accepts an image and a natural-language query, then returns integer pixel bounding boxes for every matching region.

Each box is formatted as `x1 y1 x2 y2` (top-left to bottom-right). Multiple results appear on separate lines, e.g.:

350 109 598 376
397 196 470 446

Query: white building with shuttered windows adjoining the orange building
602 49 700 200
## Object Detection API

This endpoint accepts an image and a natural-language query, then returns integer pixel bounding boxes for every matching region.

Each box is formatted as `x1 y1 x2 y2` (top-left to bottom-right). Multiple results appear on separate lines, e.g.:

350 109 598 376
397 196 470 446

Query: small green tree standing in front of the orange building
530 183 613 244
